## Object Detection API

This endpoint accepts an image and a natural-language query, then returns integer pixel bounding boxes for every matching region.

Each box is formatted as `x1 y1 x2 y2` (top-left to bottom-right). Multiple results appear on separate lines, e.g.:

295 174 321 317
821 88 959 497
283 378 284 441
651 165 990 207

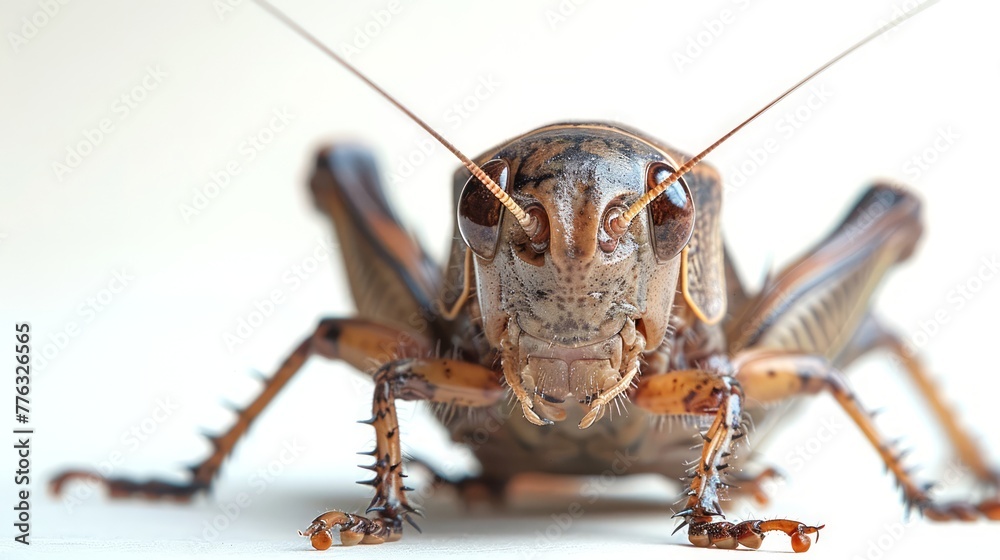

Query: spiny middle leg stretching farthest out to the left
50 319 428 501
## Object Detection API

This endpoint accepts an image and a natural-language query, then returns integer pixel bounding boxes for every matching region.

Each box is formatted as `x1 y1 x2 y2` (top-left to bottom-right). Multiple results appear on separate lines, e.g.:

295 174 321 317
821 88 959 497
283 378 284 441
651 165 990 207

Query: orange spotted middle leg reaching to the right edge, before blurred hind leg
733 350 1000 520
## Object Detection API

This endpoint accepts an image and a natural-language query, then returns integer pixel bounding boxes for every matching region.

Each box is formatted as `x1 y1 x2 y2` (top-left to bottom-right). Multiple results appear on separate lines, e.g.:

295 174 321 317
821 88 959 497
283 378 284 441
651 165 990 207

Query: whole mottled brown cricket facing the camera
54 0 1000 552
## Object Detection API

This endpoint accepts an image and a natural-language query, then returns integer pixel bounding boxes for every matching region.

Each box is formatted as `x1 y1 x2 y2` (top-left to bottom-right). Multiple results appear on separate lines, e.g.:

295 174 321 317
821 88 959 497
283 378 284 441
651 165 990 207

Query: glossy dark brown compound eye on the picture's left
458 159 510 260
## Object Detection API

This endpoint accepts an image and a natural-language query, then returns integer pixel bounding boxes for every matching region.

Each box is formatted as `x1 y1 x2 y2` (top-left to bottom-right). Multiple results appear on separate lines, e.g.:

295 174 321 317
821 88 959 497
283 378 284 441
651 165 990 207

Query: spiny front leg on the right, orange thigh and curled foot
633 370 823 552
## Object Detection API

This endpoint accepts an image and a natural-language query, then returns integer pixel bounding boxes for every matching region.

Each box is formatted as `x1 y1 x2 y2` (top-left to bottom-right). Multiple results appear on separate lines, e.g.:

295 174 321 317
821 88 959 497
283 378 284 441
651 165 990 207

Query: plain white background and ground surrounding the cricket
0 0 1000 558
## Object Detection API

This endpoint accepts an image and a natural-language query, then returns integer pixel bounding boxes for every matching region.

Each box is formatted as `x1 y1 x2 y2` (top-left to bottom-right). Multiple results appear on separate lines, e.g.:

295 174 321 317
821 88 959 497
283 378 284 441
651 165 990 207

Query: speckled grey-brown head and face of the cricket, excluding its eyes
460 124 694 427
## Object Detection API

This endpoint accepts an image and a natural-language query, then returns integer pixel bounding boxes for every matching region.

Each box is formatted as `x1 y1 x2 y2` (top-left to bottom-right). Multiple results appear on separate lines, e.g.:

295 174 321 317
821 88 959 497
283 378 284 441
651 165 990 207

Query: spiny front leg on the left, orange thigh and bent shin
302 359 504 550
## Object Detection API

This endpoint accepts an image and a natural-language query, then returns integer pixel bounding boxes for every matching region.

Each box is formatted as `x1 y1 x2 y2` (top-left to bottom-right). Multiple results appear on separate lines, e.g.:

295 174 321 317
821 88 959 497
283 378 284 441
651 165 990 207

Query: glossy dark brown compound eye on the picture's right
646 163 694 263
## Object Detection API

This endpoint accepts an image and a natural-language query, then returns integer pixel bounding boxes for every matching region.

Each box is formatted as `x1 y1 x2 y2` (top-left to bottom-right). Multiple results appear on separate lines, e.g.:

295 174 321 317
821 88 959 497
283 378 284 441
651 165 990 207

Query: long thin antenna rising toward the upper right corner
611 0 937 232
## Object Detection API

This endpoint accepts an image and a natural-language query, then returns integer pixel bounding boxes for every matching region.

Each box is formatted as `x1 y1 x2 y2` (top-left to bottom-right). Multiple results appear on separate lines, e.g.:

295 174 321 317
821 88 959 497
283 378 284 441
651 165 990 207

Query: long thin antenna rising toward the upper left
254 0 539 237
